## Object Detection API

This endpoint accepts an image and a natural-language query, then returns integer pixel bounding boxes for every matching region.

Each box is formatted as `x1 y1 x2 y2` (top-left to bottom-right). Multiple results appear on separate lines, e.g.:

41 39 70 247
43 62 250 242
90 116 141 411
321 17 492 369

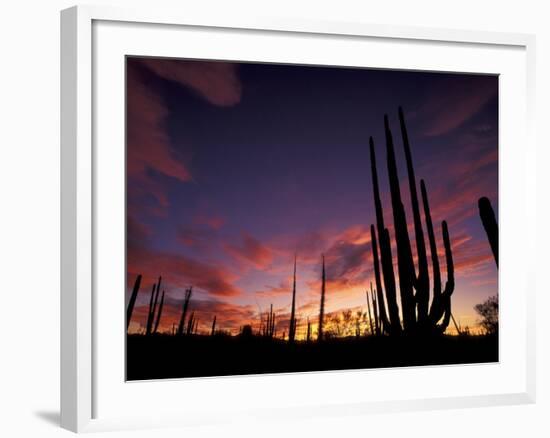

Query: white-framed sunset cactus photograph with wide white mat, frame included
61 7 536 431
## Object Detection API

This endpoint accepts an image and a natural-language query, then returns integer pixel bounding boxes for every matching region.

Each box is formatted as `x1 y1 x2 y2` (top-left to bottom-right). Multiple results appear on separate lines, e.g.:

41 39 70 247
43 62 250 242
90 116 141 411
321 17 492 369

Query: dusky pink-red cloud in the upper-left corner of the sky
126 58 242 216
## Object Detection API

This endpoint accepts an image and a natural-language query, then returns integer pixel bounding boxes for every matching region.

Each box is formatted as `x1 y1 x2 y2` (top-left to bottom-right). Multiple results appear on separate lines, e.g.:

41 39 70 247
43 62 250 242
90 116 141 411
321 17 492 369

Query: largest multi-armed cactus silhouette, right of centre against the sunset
369 108 455 335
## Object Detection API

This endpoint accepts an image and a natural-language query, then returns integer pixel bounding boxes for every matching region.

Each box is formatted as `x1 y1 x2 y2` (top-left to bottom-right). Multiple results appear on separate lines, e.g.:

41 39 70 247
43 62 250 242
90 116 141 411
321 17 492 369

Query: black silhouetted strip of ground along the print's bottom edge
127 335 498 380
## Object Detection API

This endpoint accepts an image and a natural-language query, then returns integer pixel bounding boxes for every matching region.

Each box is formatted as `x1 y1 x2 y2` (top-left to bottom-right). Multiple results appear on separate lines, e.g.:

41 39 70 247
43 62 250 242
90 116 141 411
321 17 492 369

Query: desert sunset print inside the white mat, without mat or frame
125 57 499 380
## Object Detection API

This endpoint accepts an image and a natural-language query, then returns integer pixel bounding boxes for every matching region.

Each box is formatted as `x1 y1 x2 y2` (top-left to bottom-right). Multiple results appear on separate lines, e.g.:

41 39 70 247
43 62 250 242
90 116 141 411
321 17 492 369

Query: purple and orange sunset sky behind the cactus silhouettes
126 58 498 337
